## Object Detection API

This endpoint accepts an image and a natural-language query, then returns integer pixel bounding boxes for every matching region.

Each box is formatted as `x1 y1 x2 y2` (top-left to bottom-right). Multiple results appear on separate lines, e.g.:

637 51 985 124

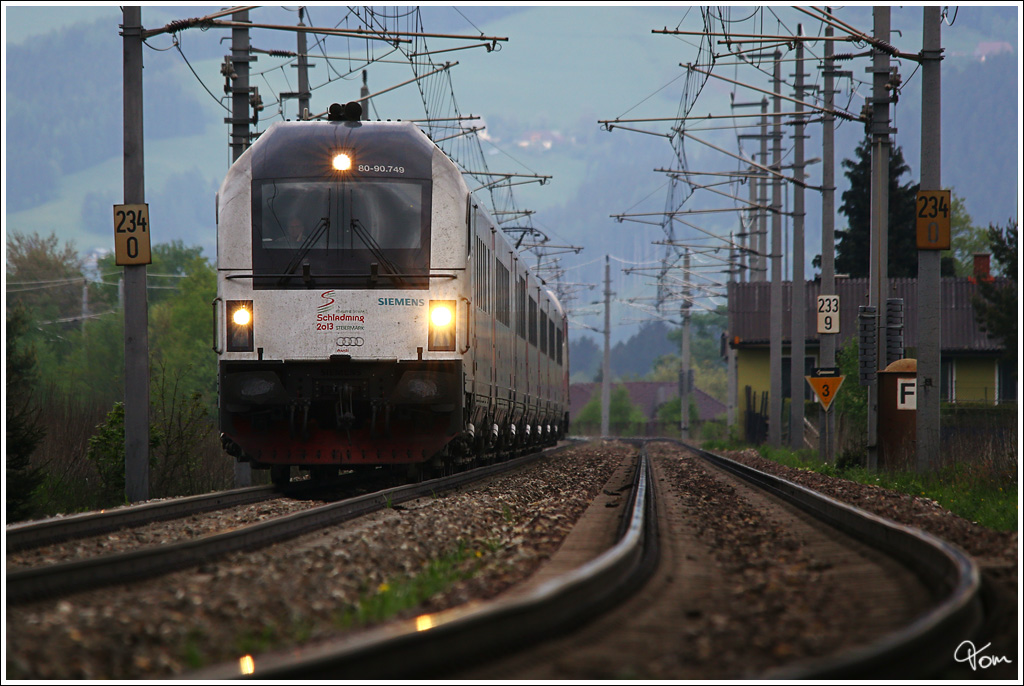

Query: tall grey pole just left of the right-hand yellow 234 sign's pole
867 7 895 469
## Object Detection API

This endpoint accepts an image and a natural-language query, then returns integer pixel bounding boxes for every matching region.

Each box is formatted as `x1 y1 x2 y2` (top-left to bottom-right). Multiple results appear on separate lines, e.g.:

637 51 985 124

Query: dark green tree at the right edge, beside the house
973 220 1019 359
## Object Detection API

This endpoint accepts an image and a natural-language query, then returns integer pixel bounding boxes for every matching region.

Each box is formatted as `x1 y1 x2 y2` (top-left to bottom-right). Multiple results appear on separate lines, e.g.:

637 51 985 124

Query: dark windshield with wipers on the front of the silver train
253 178 430 289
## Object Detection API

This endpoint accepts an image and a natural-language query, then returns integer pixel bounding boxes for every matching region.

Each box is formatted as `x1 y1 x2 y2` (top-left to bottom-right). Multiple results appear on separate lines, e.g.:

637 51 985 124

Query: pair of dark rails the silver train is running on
6 448 558 605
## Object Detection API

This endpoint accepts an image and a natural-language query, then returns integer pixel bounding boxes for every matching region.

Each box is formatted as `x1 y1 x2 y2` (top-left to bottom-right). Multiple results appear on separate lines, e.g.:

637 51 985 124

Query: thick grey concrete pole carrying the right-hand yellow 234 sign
918 5 942 471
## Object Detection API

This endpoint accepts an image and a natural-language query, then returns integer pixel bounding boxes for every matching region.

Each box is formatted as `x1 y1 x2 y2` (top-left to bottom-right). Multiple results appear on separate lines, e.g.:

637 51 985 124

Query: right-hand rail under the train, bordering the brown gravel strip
6 446 564 607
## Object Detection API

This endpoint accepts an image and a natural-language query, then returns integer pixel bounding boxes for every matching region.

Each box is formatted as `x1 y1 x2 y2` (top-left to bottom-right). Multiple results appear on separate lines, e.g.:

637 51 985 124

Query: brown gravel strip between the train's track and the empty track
5 443 635 679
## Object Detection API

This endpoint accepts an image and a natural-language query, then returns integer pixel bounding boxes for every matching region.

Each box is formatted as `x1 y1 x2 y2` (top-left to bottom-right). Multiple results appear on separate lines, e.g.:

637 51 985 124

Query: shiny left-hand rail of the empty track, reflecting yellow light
185 452 659 681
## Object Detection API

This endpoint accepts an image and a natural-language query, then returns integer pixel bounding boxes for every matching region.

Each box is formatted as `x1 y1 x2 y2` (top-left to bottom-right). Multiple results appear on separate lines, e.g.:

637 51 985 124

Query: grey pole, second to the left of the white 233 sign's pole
768 55 782 447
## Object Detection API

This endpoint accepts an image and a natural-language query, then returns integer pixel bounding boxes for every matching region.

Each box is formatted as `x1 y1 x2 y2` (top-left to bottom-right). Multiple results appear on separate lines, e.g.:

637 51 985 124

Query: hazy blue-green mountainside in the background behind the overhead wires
4 5 1021 341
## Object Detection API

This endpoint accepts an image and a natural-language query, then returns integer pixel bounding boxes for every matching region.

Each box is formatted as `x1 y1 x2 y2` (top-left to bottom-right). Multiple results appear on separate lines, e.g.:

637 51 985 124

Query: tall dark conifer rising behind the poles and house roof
827 137 954 278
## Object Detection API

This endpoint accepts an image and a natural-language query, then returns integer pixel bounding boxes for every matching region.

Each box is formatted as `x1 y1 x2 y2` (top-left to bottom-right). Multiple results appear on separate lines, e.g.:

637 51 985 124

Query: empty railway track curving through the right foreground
190 440 982 679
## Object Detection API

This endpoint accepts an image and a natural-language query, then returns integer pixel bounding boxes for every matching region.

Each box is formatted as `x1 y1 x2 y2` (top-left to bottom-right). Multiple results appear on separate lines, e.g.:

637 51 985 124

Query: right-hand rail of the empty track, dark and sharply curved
684 441 984 680
